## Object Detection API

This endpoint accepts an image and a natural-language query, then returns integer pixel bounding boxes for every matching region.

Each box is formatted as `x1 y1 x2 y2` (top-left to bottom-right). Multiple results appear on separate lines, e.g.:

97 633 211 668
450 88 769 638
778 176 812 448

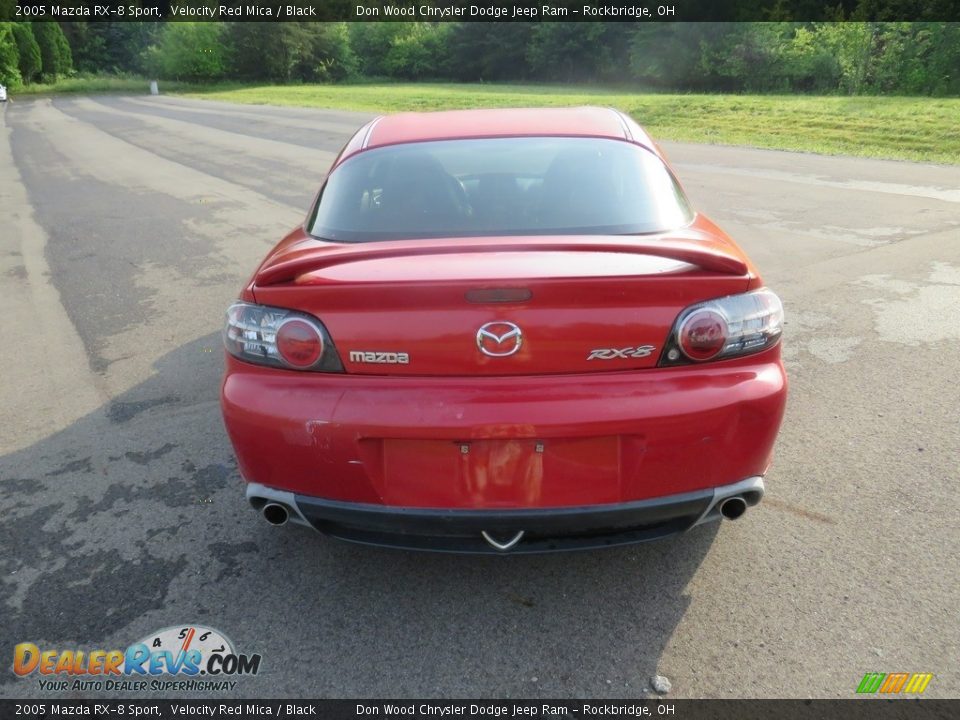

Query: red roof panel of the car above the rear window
360 107 652 149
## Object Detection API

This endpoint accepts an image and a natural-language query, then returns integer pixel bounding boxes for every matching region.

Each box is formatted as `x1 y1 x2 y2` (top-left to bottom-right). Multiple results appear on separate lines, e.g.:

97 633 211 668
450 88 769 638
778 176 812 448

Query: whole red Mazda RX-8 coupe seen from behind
221 108 786 552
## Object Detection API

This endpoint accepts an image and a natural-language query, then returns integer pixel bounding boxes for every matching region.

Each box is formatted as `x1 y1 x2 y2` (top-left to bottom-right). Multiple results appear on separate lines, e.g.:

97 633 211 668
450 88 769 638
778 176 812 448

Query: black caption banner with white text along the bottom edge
0 697 960 720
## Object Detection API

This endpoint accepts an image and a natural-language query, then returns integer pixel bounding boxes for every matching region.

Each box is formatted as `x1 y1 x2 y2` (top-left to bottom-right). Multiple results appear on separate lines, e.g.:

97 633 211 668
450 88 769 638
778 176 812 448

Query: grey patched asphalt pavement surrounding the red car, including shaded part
0 96 960 698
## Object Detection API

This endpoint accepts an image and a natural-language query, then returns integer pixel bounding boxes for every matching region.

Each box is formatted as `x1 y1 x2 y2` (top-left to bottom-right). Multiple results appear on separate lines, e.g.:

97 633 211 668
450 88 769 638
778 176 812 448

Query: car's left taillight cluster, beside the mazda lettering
223 302 343 372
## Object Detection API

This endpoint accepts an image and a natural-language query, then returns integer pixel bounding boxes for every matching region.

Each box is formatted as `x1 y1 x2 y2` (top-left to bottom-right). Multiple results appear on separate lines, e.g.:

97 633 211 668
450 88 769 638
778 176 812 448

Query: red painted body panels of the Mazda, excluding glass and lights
222 108 786 508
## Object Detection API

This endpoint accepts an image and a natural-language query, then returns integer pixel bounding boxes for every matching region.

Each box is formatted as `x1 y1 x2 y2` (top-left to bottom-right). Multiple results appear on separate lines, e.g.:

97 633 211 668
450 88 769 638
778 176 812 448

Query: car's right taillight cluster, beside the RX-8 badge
659 288 783 367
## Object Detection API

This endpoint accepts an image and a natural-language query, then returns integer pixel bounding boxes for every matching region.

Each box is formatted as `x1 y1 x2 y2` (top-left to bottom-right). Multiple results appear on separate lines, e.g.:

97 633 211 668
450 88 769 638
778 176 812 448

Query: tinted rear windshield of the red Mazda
311 137 692 242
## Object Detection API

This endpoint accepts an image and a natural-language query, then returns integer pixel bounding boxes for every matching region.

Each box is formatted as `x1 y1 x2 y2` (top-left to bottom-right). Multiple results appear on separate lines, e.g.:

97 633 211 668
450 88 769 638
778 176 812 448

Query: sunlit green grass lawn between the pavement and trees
180 83 960 164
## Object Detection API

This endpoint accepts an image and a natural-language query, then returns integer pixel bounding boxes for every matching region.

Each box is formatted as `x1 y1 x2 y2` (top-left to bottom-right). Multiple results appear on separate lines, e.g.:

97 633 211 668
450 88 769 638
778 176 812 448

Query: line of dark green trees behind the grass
0 22 960 95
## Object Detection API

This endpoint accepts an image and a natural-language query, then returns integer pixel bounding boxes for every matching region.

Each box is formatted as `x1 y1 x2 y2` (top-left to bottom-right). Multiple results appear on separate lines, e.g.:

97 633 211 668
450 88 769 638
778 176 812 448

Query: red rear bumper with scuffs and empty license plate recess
221 346 787 506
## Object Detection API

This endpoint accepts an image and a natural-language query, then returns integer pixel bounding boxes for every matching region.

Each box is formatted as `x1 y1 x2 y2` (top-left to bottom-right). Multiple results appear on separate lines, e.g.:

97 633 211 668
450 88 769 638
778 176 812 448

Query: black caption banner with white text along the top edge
0 0 960 23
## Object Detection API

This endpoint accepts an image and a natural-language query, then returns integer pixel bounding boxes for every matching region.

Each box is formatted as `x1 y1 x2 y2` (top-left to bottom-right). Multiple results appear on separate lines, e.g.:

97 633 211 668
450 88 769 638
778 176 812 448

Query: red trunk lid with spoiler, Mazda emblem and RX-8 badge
254 237 749 376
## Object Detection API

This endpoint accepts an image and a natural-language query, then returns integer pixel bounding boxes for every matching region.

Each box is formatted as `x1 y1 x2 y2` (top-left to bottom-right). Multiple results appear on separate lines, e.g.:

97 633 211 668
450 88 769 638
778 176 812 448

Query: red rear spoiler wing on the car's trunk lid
254 233 748 287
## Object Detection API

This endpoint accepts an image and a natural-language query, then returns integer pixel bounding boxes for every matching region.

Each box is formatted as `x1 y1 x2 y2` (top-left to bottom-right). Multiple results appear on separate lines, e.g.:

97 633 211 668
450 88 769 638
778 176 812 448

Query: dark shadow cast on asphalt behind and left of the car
0 333 718 698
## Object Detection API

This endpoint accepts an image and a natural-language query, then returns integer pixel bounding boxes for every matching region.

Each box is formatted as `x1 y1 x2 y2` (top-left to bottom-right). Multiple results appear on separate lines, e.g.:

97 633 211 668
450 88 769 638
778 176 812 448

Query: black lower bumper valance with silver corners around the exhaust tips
247 477 764 554
